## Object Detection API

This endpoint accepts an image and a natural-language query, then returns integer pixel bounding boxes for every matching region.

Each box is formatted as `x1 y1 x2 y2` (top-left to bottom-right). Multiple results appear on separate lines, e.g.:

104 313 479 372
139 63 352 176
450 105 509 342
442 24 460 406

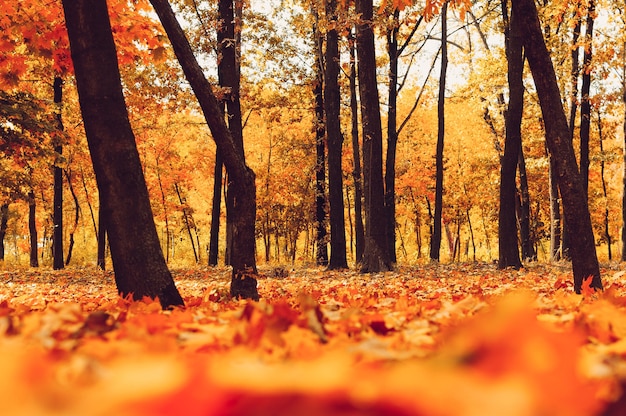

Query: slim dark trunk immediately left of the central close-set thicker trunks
313 8 328 266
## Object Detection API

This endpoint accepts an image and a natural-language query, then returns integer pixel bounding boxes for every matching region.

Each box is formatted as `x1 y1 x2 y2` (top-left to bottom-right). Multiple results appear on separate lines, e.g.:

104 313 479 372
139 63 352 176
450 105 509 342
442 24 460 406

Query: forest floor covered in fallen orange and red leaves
0 264 626 416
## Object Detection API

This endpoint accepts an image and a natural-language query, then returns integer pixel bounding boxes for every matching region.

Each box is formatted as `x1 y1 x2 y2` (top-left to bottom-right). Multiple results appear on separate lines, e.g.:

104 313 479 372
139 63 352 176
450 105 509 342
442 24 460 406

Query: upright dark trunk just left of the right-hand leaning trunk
498 1 524 269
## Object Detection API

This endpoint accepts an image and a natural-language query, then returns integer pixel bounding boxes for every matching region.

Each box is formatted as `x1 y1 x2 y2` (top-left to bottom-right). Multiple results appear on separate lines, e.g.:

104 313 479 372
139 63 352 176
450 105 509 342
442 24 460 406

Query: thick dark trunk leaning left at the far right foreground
513 0 602 293
